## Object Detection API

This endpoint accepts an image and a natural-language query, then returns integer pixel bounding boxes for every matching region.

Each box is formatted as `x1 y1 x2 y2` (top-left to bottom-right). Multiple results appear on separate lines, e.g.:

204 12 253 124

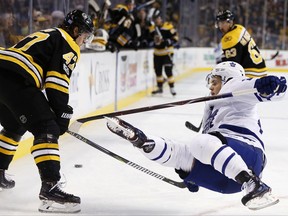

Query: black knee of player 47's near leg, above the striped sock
31 119 60 139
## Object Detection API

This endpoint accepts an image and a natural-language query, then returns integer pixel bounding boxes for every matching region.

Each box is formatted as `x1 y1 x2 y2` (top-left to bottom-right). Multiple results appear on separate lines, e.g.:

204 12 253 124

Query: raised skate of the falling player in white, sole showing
105 117 155 153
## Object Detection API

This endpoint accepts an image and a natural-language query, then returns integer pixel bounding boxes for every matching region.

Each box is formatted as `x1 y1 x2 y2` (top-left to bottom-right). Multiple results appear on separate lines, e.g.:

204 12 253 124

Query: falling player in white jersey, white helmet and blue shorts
107 61 287 210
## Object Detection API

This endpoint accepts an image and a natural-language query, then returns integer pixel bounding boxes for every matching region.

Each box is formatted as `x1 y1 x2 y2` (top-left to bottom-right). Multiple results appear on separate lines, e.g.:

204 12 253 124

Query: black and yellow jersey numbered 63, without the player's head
221 24 267 77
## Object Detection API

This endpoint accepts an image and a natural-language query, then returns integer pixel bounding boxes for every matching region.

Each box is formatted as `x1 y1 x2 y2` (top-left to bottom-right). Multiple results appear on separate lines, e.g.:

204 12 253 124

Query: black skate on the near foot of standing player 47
39 182 81 213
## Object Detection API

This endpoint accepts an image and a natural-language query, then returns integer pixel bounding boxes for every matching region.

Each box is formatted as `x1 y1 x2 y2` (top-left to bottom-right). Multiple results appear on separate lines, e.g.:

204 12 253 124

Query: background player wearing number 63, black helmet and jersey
215 10 267 77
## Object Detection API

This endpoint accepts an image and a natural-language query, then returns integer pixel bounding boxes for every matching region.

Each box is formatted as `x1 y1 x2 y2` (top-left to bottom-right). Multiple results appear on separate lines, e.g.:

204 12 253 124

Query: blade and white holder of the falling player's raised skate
104 116 135 139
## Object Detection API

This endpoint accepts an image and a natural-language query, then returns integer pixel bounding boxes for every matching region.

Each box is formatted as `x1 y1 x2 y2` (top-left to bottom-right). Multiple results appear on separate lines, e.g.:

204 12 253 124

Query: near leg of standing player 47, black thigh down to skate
22 88 81 213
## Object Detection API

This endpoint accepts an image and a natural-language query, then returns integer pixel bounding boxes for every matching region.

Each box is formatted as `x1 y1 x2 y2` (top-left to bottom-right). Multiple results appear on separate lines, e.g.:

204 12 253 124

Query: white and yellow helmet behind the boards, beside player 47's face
86 29 109 51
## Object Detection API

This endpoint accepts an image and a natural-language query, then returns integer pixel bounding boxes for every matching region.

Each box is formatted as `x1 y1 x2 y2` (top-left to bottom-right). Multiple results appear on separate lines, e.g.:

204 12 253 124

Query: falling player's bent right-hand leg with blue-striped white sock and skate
182 133 279 210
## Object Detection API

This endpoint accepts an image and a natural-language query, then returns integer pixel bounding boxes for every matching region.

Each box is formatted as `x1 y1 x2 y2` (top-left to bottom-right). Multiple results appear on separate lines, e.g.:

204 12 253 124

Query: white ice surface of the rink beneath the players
0 72 288 216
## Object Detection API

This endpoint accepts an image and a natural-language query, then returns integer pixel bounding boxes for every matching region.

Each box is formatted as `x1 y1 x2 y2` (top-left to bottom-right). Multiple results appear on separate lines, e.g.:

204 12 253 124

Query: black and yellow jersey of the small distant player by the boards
149 22 179 56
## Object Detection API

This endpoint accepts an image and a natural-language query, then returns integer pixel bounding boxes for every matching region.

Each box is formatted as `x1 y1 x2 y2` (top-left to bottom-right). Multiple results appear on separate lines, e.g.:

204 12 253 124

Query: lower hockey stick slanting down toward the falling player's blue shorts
67 130 186 188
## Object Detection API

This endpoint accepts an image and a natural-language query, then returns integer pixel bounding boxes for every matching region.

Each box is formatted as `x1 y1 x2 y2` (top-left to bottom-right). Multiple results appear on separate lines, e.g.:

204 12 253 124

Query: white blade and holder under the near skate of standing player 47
38 200 81 213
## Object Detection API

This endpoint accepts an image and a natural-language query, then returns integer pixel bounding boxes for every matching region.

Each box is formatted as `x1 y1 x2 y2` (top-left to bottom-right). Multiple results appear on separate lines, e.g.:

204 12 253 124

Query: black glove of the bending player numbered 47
55 105 73 135
